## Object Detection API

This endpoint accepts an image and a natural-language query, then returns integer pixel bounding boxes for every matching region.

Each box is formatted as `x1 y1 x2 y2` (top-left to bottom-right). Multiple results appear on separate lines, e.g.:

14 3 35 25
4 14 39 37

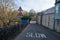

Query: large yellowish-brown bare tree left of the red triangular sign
0 0 18 26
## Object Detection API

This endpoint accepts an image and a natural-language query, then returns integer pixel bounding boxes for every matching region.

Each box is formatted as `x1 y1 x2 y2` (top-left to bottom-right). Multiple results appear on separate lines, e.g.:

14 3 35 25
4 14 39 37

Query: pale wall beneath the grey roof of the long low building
37 14 54 30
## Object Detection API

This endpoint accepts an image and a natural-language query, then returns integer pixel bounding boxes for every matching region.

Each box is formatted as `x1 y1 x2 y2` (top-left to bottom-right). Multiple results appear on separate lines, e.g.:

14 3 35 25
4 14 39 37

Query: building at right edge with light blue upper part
55 0 60 32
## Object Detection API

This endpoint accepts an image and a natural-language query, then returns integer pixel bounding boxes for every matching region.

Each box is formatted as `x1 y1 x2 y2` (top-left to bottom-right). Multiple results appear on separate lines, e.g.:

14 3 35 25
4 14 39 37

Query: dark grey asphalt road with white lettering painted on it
14 23 60 40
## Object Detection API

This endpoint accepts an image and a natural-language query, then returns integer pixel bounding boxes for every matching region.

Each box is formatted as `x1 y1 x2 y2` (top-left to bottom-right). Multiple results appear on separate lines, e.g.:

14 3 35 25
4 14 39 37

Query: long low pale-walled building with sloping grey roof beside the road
36 7 60 32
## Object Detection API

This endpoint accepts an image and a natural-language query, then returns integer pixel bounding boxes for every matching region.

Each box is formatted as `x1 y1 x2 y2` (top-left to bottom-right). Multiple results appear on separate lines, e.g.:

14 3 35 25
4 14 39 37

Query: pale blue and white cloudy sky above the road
15 0 55 12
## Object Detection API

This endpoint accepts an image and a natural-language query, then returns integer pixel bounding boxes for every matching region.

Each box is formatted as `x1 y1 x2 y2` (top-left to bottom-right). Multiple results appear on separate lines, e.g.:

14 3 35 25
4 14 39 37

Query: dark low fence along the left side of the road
0 25 20 40
